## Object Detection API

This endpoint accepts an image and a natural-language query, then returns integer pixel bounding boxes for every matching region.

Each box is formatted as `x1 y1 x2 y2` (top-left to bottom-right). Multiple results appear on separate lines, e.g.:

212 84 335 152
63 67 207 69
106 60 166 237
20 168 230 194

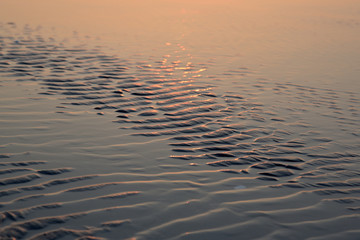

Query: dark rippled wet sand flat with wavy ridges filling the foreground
0 23 360 239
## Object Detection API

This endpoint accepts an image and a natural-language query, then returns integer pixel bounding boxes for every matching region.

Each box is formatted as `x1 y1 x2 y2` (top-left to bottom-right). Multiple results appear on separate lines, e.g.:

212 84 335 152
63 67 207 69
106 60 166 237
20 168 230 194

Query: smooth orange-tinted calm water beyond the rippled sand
0 0 360 90
